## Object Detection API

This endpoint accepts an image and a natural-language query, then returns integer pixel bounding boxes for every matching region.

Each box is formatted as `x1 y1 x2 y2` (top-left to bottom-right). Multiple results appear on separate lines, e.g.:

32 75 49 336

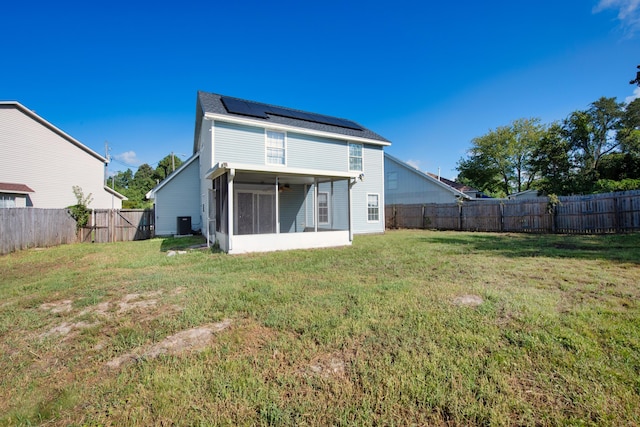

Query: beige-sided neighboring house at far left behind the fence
0 101 126 209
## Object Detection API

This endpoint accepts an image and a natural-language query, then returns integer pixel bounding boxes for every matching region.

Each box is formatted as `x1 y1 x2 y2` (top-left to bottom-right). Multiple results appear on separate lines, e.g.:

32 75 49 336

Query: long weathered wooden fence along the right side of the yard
385 191 640 234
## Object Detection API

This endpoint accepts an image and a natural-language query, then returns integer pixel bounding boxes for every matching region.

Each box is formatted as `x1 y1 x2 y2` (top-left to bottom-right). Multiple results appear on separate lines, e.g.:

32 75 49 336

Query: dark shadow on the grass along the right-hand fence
419 233 640 264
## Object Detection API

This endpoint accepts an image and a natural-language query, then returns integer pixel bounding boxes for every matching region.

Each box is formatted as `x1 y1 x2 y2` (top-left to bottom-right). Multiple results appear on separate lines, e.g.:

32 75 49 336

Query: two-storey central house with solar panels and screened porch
149 92 390 253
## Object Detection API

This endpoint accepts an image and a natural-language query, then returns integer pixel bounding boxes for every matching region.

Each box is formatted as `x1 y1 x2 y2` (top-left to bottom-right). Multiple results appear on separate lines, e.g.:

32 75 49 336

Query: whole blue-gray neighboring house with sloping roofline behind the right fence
384 153 471 205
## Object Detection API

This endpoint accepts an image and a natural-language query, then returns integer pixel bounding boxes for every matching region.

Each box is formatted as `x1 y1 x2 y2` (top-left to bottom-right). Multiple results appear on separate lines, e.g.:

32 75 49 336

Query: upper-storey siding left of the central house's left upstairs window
213 122 265 165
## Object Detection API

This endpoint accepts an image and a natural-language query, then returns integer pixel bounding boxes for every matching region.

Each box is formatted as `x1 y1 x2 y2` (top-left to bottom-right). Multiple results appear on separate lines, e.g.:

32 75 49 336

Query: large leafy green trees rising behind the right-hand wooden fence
457 97 640 197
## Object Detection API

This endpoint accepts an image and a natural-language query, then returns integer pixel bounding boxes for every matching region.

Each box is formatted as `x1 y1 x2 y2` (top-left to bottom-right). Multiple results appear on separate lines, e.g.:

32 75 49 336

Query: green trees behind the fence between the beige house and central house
107 154 182 209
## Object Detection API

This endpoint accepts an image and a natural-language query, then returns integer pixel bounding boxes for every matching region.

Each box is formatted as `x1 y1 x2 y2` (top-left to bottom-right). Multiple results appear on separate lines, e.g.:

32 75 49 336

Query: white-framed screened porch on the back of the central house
207 166 355 253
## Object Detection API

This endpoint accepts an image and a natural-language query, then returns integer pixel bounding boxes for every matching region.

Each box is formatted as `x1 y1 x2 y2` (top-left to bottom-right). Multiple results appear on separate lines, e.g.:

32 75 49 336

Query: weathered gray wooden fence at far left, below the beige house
0 208 77 255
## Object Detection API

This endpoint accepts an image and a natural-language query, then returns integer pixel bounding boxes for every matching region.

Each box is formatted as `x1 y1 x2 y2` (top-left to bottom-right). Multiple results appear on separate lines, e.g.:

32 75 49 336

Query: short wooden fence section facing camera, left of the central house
80 209 155 243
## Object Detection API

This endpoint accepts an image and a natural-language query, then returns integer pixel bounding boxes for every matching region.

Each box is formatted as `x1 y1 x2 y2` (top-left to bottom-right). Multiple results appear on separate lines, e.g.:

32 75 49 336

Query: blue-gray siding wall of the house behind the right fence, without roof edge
384 158 457 205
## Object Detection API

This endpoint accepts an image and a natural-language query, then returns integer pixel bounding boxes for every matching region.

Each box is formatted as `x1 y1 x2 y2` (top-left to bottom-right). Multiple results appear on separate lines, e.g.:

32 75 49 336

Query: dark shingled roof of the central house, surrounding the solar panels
194 91 390 147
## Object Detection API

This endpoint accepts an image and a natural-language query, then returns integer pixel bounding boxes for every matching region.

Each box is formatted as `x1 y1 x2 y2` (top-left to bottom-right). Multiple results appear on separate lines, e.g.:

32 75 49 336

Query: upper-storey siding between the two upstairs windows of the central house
287 132 349 172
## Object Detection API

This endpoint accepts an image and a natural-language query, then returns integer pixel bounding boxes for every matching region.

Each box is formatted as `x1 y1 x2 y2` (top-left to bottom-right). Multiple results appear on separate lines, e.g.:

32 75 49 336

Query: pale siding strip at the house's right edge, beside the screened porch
351 144 385 234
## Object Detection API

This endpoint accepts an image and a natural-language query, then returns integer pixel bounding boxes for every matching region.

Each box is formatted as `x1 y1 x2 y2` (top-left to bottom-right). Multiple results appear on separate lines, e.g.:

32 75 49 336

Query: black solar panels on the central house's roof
220 96 364 130
